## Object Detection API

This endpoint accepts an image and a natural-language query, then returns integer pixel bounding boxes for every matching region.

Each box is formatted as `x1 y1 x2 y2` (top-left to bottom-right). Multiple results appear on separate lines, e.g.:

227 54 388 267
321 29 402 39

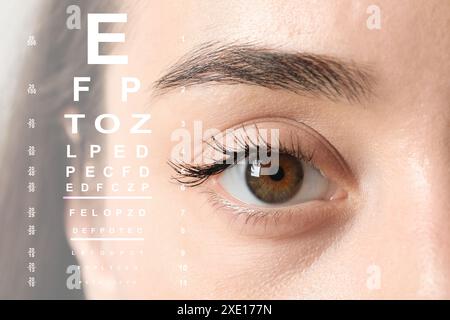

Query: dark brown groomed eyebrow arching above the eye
153 42 374 102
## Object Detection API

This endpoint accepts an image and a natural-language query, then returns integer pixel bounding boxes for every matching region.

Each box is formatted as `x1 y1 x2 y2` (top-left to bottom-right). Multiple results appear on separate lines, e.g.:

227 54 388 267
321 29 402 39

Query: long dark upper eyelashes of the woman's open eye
168 125 317 187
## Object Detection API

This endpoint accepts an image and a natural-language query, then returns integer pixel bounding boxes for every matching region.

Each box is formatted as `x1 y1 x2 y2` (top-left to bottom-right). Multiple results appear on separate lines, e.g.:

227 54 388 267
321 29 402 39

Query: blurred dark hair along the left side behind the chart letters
0 0 117 299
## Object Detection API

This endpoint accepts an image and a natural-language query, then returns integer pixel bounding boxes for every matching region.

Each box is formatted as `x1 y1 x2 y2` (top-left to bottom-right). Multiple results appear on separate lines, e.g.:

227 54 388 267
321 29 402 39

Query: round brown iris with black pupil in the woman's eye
245 154 303 203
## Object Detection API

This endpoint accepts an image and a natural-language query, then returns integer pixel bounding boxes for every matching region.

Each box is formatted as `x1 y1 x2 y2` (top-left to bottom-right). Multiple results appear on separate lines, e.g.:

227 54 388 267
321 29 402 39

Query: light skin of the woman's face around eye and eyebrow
67 0 450 299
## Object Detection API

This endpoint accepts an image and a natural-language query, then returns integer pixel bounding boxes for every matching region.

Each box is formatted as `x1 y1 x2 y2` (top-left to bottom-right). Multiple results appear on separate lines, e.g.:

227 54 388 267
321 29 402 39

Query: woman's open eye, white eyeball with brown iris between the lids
218 154 330 207
